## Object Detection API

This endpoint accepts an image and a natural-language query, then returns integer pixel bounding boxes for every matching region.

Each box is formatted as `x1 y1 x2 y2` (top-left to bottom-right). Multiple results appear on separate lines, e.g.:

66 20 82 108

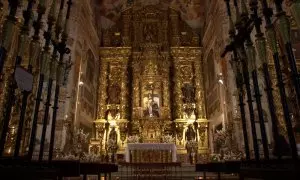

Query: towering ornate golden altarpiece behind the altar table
90 6 208 159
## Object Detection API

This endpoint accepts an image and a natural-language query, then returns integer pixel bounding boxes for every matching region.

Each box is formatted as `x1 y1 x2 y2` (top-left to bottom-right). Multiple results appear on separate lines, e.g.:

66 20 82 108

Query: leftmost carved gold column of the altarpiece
97 58 108 120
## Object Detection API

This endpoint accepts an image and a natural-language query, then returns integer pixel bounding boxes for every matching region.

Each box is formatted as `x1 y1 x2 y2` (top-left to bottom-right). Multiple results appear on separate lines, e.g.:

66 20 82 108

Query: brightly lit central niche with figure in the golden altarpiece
143 93 159 117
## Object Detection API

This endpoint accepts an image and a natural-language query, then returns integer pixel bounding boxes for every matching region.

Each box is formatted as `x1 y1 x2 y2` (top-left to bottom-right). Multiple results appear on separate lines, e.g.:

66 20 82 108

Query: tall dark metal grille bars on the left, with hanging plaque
0 0 72 161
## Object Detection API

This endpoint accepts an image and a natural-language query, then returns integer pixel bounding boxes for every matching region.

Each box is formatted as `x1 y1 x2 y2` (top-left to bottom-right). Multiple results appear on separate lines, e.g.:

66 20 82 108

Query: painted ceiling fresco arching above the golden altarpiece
98 0 204 29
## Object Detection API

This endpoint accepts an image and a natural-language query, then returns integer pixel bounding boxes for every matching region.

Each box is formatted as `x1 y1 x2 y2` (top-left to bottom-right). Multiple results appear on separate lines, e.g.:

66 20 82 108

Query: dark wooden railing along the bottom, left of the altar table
0 158 118 180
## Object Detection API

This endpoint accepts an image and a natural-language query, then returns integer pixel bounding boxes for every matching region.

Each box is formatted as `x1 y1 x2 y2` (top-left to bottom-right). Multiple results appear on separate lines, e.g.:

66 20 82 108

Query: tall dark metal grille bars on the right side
222 0 299 160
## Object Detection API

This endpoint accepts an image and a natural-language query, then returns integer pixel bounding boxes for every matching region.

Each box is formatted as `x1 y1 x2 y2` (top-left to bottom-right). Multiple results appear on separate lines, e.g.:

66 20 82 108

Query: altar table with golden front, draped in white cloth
125 143 177 163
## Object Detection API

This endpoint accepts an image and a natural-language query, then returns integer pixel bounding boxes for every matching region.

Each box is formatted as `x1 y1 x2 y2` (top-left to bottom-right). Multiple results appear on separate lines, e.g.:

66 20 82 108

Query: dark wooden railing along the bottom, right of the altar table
196 159 300 180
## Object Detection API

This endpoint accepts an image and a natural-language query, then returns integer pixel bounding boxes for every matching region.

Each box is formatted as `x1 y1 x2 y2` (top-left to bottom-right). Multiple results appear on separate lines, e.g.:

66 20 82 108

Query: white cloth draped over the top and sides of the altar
125 143 177 162
